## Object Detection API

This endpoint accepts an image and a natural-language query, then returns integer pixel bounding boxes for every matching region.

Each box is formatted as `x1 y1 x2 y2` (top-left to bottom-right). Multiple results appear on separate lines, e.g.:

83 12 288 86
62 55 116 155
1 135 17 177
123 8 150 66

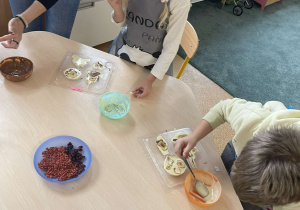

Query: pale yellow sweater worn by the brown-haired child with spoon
203 98 300 210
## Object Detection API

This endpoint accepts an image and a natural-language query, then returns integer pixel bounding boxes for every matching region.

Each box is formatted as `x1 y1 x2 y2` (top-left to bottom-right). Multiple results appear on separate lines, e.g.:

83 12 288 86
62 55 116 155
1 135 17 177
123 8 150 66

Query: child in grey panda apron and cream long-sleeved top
108 0 190 98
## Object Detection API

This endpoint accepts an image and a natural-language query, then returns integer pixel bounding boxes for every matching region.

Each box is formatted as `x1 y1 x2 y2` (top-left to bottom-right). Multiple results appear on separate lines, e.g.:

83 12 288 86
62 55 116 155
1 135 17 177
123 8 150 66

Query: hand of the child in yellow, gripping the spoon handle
174 135 198 158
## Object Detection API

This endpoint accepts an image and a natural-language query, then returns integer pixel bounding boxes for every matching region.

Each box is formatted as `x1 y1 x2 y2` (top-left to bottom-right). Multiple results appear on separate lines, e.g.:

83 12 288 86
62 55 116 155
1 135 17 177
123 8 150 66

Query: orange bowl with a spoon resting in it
184 170 222 206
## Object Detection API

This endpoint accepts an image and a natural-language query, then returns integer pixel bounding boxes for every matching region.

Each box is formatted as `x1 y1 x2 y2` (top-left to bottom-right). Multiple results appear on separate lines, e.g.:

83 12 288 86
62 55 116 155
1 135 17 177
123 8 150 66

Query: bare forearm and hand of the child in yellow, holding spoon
174 120 212 158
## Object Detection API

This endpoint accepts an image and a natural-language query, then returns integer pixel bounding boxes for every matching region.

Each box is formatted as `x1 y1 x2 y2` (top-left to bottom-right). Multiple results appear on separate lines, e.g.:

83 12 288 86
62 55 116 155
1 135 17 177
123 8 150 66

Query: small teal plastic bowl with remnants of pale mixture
99 92 131 119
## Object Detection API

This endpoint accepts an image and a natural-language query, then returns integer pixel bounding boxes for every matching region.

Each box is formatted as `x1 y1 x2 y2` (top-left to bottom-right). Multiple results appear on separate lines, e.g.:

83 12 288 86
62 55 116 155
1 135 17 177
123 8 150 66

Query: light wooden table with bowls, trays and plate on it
0 32 242 210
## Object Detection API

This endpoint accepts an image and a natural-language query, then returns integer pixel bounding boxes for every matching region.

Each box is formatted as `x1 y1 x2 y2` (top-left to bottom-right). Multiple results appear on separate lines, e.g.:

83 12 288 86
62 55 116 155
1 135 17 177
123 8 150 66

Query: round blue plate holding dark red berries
33 136 92 183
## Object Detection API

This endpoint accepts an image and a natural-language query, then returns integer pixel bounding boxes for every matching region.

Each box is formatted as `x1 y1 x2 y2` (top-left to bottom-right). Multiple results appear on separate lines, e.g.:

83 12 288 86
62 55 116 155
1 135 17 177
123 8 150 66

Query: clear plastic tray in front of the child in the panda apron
50 52 114 94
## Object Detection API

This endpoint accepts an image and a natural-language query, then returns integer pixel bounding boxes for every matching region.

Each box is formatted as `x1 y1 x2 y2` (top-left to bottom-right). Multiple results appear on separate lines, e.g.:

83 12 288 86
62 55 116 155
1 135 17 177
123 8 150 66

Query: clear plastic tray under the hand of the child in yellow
143 128 212 188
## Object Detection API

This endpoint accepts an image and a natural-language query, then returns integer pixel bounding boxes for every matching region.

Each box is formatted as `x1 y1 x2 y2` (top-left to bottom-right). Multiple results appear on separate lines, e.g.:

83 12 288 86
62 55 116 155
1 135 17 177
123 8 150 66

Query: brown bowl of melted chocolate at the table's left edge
0 57 33 82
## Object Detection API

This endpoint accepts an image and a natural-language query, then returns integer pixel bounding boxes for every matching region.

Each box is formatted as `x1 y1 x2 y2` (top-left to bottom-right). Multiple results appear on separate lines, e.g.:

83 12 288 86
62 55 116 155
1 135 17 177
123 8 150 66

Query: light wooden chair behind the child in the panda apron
176 21 199 79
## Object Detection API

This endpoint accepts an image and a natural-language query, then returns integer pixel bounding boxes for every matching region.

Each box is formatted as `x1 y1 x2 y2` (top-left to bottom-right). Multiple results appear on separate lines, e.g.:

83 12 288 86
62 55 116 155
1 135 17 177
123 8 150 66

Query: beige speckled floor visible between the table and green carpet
95 42 234 154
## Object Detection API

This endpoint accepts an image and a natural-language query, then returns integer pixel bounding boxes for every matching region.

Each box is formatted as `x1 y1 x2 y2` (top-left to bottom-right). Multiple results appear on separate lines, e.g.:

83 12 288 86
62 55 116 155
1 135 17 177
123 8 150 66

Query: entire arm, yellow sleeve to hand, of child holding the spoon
175 98 270 155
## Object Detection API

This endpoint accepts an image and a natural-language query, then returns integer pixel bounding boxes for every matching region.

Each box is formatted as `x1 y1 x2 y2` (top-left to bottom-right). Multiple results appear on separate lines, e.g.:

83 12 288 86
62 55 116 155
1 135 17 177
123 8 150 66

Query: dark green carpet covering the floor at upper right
178 0 300 109
